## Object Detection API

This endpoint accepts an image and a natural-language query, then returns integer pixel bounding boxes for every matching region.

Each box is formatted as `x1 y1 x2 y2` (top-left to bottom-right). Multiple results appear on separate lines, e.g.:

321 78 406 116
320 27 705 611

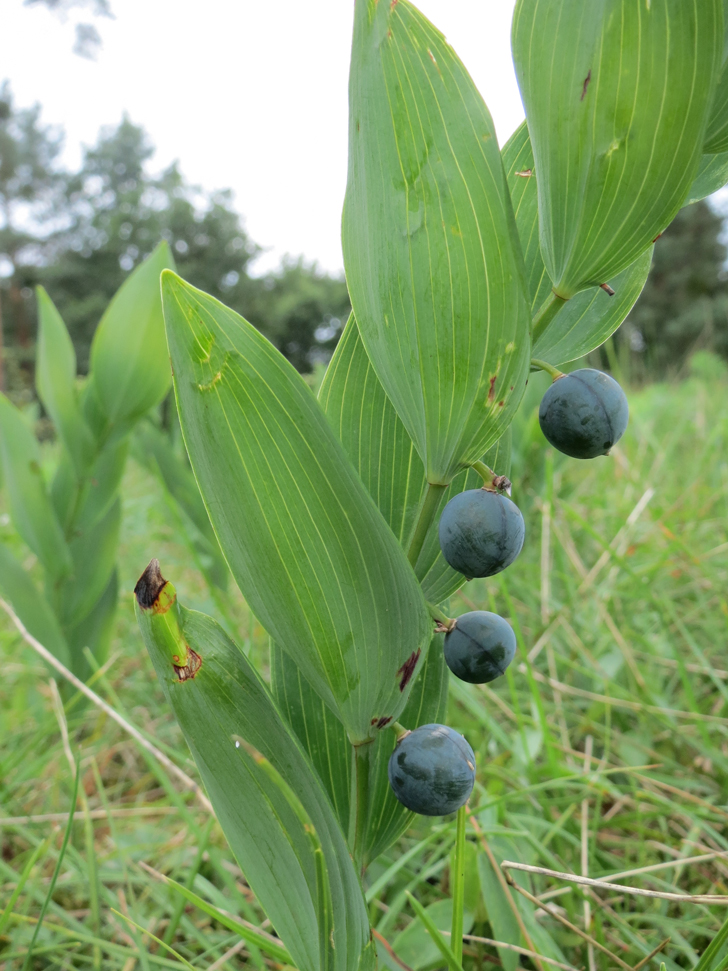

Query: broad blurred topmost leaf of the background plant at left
91 243 174 426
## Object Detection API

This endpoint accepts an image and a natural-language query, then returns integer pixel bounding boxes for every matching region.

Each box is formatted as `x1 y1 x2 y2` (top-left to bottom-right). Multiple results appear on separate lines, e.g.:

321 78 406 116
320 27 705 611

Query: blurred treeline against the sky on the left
0 84 349 384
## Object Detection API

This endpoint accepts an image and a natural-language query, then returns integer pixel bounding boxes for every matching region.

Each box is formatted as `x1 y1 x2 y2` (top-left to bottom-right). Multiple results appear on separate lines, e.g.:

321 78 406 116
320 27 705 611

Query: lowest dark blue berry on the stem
389 725 475 816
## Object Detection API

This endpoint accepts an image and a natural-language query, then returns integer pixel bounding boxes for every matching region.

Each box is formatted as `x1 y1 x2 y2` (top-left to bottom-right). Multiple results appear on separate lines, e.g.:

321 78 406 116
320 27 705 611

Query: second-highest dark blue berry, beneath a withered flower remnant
439 489 526 579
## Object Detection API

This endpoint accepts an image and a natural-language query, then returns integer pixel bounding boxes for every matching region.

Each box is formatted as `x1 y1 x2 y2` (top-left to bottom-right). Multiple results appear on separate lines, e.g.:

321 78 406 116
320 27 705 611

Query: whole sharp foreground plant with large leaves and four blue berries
131 0 728 971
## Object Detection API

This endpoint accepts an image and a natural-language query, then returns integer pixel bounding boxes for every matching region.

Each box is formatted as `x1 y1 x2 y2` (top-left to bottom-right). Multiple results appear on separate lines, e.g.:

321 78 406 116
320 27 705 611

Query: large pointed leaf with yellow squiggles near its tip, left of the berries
162 273 431 743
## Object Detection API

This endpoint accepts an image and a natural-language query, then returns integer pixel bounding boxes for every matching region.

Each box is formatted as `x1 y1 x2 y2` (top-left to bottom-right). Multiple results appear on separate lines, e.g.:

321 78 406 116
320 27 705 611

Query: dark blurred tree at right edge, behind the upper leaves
615 202 728 380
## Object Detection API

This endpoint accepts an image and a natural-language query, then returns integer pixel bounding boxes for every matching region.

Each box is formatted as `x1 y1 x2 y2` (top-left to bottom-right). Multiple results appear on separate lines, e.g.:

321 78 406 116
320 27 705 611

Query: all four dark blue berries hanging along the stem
389 368 629 816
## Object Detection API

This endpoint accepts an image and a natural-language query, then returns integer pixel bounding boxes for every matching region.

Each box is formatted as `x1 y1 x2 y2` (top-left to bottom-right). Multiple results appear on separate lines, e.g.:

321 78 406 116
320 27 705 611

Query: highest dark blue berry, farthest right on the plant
538 368 629 459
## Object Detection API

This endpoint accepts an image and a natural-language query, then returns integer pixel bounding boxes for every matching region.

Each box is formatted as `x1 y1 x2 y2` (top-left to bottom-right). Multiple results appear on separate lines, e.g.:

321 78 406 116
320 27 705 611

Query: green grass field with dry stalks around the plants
0 358 728 971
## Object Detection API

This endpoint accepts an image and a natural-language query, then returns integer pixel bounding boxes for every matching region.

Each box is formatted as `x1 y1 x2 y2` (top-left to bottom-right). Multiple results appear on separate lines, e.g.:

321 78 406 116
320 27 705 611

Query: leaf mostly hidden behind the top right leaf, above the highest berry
502 121 652 364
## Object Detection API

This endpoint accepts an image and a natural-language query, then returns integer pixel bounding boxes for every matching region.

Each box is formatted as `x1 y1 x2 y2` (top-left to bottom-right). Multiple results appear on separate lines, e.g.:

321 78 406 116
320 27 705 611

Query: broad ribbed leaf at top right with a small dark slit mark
512 0 723 298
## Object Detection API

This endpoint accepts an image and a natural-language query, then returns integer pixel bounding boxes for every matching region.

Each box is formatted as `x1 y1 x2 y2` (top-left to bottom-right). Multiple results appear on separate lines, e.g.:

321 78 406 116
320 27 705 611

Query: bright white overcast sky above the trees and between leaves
0 0 523 271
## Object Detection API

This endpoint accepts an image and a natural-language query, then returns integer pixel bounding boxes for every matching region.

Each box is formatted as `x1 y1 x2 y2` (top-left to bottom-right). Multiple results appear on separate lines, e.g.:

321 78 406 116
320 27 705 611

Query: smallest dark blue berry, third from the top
445 610 516 684
